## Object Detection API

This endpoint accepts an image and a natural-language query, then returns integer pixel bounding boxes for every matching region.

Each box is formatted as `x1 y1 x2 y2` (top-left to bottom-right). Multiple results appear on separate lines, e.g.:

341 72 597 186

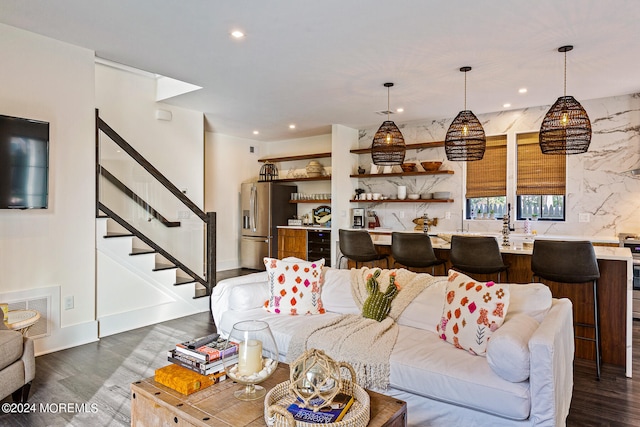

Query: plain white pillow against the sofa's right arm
487 313 539 383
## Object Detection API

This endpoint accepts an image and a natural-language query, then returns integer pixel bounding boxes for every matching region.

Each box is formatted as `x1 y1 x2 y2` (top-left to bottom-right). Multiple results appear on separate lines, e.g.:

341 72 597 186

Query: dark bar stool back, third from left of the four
450 235 509 282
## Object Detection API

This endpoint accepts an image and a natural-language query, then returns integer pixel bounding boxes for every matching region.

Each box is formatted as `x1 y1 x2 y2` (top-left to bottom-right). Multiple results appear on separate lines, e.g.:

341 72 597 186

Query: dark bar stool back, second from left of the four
391 232 447 275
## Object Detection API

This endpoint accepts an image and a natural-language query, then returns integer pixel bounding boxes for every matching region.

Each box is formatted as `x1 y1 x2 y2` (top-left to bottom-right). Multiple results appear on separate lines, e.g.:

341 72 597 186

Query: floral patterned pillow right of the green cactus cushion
436 270 509 355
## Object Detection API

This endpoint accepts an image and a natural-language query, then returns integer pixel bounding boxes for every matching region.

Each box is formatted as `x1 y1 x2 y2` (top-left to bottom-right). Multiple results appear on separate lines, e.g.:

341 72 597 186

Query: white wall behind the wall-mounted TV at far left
0 24 97 352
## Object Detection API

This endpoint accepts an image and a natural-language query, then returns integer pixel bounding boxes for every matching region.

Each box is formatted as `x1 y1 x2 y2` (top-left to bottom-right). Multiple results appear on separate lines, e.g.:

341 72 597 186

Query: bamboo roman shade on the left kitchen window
467 135 507 199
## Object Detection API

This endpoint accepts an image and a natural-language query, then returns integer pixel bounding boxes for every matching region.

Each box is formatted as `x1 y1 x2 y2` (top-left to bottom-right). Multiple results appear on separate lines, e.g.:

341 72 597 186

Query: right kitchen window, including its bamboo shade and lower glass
516 132 567 221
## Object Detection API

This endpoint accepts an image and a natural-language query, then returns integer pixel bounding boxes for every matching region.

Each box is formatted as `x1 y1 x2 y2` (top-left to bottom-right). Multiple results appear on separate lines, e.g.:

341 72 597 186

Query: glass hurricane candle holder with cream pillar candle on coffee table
222 320 278 400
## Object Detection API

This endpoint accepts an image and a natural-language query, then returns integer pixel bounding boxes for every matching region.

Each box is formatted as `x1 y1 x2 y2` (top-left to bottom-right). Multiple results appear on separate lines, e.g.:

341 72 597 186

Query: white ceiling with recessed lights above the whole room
0 0 640 141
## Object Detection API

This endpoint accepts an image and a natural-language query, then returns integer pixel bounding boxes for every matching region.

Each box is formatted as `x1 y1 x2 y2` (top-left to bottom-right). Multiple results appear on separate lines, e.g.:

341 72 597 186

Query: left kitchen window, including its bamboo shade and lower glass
466 135 507 219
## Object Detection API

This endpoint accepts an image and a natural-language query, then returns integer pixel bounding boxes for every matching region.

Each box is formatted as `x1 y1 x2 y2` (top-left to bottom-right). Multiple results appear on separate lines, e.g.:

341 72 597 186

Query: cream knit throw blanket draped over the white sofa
287 267 441 389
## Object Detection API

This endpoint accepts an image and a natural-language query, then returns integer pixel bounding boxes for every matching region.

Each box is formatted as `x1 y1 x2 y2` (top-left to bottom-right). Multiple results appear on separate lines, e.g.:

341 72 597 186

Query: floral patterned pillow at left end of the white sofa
264 258 325 315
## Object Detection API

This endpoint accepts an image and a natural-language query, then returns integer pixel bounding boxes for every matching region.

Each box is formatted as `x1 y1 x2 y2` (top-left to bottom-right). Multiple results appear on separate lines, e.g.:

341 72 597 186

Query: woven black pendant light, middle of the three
444 67 487 162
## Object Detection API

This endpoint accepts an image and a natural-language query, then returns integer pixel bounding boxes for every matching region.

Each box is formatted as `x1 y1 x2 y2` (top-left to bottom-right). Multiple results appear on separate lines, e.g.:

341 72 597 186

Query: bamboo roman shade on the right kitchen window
516 132 567 196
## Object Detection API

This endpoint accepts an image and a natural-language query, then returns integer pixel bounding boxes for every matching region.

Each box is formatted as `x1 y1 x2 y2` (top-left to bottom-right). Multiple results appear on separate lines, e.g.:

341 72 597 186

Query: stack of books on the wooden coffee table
167 334 238 375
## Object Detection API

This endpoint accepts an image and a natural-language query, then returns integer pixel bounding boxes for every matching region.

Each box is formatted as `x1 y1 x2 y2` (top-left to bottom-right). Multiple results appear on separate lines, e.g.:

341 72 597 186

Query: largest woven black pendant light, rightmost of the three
540 46 591 154
